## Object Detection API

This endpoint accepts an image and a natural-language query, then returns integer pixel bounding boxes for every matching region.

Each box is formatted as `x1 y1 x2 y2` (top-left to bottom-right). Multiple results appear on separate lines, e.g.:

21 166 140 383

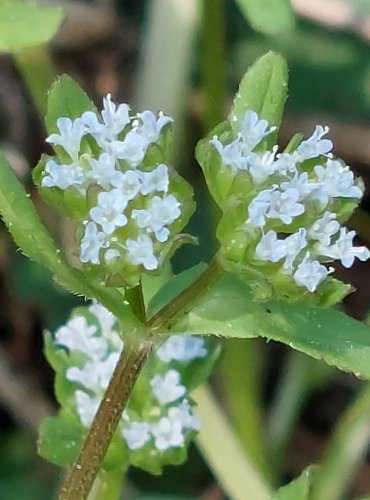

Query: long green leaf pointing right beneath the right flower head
175 274 370 379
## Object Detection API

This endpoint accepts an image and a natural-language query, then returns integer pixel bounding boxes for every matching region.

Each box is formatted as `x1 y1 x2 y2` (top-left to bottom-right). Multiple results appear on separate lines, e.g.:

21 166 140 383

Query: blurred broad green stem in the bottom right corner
310 383 370 500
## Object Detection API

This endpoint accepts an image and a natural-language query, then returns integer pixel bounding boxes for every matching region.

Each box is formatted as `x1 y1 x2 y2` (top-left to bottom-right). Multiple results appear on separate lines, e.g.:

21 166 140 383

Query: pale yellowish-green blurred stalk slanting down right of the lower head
192 385 270 500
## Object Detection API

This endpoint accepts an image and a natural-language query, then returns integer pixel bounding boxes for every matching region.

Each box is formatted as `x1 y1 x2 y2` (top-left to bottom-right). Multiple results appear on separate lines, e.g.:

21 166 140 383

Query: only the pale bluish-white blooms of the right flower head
210 111 370 292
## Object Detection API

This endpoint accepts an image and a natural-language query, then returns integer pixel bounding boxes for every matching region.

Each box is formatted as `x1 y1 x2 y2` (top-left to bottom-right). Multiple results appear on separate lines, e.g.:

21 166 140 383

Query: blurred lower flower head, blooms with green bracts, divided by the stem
53 303 214 468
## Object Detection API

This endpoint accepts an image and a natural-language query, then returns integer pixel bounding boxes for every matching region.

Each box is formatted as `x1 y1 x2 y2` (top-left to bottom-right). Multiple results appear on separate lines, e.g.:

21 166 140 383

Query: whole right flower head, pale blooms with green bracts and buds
204 110 370 295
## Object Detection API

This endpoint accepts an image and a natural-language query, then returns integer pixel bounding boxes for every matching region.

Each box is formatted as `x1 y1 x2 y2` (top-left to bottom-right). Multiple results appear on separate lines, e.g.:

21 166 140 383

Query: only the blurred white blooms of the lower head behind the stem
55 303 207 452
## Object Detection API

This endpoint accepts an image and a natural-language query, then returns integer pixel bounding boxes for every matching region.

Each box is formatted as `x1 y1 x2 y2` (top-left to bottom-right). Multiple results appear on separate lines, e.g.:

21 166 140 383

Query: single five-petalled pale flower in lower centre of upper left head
90 189 127 234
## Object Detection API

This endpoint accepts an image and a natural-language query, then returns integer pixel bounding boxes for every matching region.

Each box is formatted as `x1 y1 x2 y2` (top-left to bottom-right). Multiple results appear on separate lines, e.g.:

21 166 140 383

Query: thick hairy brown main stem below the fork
58 341 152 500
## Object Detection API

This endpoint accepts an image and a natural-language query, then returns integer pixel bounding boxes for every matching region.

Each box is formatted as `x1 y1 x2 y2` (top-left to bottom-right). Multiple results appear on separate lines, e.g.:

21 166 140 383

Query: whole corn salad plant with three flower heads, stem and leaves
0 33 370 500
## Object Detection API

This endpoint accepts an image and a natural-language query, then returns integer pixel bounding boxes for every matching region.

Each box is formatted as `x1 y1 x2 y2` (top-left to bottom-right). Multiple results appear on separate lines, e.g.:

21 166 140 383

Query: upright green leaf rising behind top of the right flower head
230 51 288 145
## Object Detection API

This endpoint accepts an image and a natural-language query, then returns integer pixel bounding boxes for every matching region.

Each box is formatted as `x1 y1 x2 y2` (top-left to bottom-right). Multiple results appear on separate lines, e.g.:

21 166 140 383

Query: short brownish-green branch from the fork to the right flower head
147 256 222 333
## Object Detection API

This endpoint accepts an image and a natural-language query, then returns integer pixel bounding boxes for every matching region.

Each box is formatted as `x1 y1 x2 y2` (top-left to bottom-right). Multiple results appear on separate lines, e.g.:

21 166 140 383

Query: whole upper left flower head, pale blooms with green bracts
36 94 193 284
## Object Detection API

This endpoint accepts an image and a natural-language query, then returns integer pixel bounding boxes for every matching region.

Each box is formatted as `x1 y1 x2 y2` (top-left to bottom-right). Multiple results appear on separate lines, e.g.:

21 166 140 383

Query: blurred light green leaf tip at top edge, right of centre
236 0 294 35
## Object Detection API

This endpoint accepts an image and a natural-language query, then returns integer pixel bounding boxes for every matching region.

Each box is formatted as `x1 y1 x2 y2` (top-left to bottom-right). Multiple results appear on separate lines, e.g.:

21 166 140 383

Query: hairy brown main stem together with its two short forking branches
58 257 221 500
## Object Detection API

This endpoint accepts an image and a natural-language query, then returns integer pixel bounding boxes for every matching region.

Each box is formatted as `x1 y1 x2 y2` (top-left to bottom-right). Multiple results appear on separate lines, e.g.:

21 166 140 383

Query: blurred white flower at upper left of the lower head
55 316 108 360
